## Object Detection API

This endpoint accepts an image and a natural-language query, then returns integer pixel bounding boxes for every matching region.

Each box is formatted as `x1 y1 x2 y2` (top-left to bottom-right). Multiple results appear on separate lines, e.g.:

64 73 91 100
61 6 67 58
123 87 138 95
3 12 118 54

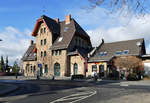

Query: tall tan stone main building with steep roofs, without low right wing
22 15 92 77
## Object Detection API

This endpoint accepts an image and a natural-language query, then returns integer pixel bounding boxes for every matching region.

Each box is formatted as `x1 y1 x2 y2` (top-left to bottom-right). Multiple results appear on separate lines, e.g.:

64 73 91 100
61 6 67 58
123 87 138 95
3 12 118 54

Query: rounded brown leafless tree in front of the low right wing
114 56 143 73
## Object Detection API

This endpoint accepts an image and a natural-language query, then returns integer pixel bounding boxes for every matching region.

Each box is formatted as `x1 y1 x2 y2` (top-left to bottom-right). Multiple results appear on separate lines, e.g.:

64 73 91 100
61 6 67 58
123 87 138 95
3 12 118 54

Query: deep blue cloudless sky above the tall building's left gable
0 0 88 30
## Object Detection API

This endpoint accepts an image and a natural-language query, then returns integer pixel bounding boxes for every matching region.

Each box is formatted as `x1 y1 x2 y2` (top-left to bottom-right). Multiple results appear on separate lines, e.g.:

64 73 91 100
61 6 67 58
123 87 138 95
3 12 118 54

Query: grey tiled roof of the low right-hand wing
89 38 144 62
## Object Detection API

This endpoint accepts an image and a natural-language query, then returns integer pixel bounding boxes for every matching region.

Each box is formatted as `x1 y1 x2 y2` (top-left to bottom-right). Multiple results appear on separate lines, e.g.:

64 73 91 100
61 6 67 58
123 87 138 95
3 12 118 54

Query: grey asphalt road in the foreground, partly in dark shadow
0 81 150 103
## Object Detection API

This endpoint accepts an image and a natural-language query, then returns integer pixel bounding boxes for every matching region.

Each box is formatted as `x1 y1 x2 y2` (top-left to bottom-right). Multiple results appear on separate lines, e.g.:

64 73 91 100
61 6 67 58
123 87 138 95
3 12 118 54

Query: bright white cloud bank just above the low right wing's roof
87 15 150 53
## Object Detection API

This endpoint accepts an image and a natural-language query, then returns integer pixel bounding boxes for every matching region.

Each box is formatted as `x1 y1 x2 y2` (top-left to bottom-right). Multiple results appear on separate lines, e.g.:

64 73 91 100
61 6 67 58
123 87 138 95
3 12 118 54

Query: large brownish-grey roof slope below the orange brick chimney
50 19 90 50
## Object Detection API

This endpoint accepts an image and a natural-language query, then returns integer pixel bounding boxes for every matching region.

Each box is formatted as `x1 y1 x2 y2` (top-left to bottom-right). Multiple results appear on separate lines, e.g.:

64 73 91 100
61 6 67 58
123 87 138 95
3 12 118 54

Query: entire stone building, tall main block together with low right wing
22 15 149 78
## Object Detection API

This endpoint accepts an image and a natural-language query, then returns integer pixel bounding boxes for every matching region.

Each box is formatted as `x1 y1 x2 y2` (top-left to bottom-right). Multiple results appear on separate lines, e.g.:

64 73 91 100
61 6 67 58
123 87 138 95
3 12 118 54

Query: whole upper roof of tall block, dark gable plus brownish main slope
32 15 91 50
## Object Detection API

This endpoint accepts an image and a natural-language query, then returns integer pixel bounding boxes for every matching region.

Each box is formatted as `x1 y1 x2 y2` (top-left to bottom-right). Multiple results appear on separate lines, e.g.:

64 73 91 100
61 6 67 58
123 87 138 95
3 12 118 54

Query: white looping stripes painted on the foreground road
50 91 97 103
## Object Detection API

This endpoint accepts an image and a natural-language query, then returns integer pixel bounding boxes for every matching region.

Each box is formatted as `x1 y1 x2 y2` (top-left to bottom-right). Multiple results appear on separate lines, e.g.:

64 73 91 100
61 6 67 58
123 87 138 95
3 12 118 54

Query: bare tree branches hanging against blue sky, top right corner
88 0 150 15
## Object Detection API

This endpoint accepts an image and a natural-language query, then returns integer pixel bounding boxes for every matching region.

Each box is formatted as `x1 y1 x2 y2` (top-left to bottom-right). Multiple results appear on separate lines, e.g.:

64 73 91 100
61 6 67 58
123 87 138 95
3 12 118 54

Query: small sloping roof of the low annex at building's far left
22 44 36 61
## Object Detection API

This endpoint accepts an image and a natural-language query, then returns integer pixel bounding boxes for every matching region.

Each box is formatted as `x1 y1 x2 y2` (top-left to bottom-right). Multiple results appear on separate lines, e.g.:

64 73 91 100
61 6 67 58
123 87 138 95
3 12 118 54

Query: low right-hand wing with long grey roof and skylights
88 38 146 77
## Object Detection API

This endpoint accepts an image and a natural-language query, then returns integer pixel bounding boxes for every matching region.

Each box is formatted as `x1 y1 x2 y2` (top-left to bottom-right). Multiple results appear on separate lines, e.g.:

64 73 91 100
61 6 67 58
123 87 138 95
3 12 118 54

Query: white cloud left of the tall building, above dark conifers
0 26 33 65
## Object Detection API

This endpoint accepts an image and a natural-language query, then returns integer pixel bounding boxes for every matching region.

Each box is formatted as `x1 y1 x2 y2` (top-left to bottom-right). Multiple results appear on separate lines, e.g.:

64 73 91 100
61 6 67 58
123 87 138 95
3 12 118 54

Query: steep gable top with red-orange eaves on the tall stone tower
32 15 60 45
